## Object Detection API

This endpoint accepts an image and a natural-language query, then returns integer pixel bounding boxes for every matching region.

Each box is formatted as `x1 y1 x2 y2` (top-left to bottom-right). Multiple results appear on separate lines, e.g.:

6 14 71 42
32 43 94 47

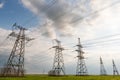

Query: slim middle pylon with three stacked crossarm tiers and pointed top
76 38 88 76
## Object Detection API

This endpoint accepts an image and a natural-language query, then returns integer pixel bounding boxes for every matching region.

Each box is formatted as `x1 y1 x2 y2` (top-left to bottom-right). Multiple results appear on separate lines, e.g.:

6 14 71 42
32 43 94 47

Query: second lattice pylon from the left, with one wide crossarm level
49 40 65 76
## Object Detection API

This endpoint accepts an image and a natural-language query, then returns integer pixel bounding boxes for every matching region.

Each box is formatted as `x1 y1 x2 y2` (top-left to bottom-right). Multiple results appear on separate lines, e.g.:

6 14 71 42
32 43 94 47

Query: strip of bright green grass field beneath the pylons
0 75 120 80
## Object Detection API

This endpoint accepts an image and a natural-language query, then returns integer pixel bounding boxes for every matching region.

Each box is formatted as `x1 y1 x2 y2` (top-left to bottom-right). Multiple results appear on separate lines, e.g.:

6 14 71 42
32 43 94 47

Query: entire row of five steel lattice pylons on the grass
0 24 119 77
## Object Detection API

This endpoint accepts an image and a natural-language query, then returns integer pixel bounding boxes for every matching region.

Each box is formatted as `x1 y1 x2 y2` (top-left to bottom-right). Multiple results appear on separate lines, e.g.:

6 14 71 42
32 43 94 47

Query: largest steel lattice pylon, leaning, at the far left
2 24 32 77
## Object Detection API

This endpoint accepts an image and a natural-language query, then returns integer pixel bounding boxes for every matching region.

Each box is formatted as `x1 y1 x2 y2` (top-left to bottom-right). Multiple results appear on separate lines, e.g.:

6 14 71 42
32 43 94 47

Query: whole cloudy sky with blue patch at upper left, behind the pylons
0 0 120 74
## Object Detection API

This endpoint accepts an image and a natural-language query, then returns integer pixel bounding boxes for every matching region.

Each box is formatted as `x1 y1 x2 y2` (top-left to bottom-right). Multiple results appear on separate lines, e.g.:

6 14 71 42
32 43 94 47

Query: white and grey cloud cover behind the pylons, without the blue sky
0 0 120 74
